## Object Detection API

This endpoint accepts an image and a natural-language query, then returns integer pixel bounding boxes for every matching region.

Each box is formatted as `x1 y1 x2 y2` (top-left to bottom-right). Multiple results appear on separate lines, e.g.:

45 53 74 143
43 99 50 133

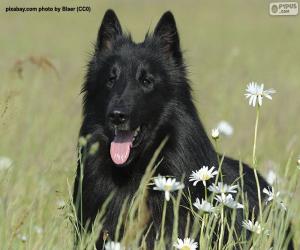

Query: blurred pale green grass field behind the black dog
0 0 300 249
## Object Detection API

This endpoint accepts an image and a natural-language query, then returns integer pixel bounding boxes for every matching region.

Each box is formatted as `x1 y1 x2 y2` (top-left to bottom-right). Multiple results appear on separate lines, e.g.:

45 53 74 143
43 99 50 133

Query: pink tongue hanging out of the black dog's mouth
110 131 134 165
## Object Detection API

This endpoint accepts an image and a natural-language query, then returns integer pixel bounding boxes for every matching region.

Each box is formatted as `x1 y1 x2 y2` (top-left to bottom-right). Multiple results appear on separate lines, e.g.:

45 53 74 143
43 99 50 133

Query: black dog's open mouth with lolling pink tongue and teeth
110 126 142 165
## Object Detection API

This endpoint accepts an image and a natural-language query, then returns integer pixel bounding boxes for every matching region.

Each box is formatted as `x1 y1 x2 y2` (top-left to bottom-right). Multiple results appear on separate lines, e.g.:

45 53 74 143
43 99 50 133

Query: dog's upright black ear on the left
97 9 122 50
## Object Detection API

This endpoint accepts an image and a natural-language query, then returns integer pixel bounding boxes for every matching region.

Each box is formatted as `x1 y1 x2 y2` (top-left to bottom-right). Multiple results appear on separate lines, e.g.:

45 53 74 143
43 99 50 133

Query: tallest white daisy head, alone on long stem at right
245 82 276 107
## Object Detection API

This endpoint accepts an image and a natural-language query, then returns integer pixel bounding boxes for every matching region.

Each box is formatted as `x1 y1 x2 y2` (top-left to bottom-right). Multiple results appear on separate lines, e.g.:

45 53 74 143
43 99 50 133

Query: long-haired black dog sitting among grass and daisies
74 10 292 249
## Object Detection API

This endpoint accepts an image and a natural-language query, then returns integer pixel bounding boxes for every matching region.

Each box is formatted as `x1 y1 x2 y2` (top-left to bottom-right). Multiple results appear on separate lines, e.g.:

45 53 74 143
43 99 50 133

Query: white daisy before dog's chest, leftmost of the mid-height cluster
153 175 184 201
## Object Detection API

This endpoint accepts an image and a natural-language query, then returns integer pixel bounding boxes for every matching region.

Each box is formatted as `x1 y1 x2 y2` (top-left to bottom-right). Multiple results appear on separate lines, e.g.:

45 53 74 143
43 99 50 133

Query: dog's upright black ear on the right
154 11 181 56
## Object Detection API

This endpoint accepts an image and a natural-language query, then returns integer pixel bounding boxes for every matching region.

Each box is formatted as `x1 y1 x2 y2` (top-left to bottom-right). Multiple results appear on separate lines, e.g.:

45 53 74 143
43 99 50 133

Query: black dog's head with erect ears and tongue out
84 10 189 166
